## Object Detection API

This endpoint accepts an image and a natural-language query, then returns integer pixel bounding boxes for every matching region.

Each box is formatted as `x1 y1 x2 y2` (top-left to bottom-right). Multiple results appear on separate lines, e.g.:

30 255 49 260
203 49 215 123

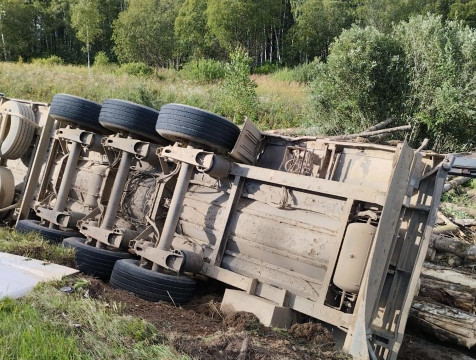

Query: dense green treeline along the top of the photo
0 0 476 68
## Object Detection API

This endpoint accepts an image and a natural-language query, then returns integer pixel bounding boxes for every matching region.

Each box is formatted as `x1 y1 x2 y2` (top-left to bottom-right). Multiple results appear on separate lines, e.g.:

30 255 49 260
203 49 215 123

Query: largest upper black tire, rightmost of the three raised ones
156 104 240 153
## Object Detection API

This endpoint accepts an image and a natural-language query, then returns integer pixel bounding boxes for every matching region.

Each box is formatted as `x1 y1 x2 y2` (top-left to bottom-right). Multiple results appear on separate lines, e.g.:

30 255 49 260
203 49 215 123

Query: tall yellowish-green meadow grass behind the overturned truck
0 62 306 130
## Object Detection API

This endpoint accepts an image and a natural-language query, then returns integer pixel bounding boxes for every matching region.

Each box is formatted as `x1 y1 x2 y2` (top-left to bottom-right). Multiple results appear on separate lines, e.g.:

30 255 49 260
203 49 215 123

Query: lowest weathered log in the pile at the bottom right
410 298 476 348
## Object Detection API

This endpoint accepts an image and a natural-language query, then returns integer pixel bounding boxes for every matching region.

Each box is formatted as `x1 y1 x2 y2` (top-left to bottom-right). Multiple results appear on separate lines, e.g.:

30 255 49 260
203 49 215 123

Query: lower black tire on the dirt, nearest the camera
110 260 197 305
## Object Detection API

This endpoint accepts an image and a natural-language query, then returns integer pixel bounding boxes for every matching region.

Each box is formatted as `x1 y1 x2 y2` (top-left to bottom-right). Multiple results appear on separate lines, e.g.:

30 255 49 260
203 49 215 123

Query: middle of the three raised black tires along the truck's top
99 99 167 144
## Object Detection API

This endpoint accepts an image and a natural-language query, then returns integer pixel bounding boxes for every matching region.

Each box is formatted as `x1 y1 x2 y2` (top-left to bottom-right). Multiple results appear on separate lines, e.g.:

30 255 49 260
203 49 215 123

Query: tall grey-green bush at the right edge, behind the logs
395 15 476 151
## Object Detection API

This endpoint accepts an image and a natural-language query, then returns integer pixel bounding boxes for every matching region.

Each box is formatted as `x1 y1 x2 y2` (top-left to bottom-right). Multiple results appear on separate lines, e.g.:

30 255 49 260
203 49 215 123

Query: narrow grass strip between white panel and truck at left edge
0 228 75 267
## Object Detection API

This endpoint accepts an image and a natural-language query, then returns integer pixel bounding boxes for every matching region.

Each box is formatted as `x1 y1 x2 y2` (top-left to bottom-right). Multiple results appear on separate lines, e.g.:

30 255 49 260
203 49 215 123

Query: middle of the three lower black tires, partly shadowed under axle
63 237 133 281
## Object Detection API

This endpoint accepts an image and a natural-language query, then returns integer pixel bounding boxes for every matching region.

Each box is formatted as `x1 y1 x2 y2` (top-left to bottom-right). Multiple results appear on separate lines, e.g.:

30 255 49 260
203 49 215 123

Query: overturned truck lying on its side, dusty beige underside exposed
1 93 466 359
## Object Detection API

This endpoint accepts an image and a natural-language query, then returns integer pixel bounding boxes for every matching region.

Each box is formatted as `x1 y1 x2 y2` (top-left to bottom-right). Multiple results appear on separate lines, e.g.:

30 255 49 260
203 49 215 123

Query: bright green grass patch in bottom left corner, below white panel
0 280 188 360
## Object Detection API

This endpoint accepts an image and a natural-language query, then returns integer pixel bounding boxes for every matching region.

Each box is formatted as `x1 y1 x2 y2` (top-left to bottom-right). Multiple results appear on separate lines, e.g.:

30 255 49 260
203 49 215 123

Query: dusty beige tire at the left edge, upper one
0 101 36 160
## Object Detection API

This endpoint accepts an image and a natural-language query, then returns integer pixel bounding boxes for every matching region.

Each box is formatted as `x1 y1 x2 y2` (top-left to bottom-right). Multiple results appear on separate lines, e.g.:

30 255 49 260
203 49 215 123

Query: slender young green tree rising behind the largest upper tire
220 48 259 124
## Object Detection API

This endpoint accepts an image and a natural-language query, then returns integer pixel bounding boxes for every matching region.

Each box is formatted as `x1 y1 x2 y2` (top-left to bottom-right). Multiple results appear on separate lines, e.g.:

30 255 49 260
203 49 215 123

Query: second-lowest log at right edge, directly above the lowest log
419 277 476 314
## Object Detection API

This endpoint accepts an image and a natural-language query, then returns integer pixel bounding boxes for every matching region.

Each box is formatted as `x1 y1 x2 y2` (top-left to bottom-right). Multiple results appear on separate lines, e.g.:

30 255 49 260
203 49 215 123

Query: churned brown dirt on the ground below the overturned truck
69 278 476 360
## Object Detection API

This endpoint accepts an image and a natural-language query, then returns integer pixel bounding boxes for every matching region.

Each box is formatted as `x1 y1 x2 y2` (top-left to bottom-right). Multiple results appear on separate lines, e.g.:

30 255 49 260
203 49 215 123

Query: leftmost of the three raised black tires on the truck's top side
50 94 108 134
